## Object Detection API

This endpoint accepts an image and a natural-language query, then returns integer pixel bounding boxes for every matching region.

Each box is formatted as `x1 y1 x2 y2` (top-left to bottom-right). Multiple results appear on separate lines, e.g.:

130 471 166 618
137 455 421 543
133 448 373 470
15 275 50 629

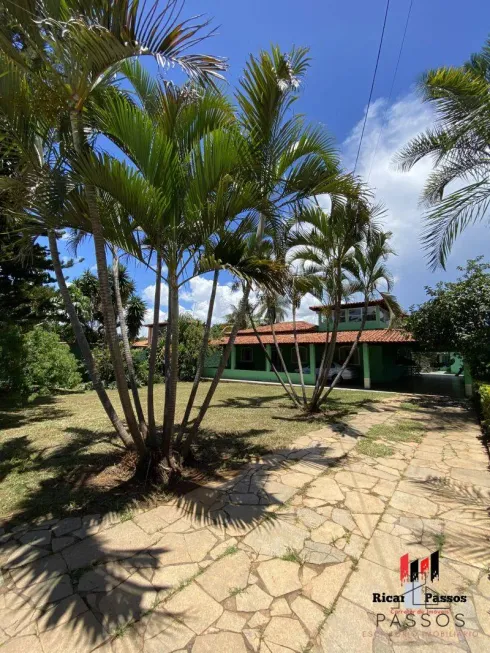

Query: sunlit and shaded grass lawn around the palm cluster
0 383 388 521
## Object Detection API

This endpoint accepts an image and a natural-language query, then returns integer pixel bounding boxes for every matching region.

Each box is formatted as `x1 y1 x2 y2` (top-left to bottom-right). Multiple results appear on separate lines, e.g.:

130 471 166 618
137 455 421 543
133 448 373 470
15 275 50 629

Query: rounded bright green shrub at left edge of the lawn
25 327 82 392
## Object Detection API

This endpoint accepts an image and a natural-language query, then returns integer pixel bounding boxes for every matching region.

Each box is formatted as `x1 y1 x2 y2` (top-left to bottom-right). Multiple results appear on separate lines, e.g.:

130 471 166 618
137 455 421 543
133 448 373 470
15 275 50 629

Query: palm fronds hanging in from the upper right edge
396 39 490 269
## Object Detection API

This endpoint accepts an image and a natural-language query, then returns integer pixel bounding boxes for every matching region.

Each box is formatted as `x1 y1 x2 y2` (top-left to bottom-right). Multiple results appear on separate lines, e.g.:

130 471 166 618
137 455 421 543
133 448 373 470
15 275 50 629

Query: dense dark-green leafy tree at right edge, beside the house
406 257 490 380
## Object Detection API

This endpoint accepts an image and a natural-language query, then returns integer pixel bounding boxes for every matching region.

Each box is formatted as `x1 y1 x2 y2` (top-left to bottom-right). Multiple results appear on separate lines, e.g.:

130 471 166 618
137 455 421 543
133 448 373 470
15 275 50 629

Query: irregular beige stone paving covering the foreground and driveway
0 396 490 653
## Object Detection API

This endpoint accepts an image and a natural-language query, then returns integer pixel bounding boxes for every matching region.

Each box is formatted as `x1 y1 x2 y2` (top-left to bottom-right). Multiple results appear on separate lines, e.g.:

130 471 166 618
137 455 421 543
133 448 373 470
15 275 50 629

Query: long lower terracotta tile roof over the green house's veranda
210 329 415 345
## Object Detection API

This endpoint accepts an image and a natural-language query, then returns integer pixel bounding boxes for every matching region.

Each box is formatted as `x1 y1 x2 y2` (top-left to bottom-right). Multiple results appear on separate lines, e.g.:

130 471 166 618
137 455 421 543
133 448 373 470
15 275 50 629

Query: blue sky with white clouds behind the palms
57 0 490 321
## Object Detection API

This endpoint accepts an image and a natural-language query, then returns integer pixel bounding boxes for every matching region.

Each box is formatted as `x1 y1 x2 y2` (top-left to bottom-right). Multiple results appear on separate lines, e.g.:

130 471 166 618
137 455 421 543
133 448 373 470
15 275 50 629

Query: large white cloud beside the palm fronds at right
342 94 488 307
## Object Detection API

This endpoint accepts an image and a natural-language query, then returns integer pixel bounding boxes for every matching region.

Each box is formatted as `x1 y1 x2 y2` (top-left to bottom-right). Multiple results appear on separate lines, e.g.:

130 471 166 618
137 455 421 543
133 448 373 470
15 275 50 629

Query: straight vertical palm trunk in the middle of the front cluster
162 268 179 468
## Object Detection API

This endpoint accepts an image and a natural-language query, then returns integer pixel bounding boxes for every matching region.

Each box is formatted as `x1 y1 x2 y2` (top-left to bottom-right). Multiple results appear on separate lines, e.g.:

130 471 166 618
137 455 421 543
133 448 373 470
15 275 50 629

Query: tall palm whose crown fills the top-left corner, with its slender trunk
0 0 224 458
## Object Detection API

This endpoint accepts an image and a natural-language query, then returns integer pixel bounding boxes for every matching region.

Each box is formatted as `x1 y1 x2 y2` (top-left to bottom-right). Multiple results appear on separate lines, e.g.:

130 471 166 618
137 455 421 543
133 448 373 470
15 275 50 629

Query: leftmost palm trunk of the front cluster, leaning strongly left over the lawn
48 230 134 449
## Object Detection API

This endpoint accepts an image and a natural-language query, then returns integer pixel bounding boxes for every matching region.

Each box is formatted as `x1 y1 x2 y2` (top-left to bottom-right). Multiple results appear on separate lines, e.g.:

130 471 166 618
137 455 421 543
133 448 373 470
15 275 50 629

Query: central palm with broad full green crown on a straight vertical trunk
77 74 255 467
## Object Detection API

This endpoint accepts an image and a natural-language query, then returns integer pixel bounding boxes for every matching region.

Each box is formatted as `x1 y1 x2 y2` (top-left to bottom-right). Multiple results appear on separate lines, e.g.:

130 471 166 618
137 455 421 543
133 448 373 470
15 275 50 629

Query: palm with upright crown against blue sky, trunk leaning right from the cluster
189 47 353 432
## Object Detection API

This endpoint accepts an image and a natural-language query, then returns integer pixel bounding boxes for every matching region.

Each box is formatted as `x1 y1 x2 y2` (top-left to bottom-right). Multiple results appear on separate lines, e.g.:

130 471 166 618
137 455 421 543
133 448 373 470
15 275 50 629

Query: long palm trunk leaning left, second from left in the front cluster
70 110 146 458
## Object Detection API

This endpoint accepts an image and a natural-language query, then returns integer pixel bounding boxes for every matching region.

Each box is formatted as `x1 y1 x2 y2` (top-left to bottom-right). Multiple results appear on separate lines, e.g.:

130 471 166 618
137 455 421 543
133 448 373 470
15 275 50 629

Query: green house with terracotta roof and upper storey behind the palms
204 300 415 388
